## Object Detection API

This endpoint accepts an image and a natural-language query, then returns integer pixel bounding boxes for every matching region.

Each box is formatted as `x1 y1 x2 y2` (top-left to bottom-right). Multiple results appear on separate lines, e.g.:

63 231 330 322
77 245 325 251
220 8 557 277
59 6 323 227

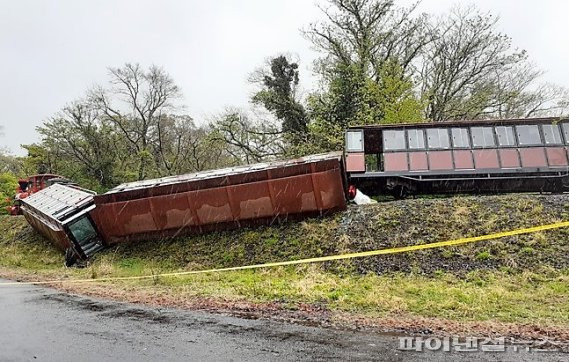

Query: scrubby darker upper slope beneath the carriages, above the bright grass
0 194 569 274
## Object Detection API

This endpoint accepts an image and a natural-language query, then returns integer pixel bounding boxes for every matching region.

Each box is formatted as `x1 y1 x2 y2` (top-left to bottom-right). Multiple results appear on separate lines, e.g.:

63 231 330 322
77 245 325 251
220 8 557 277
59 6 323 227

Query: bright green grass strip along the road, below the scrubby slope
48 263 569 326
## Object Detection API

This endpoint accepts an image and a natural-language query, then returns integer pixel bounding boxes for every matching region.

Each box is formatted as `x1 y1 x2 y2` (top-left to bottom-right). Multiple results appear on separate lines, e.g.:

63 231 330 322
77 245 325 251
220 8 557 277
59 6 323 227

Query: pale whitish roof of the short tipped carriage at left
21 184 95 222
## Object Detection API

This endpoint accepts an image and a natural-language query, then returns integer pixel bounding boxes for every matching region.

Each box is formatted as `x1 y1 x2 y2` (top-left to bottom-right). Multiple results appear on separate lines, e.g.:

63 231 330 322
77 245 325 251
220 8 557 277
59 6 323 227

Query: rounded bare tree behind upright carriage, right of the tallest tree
419 7 536 121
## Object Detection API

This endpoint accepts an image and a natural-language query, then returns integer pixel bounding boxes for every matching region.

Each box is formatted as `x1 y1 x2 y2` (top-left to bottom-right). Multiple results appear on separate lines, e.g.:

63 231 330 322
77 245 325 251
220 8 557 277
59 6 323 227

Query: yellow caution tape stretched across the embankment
0 221 569 287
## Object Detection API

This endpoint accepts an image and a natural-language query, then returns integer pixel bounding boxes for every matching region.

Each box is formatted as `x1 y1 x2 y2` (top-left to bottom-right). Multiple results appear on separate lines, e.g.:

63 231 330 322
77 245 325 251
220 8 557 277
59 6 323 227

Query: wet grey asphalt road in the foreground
0 280 569 362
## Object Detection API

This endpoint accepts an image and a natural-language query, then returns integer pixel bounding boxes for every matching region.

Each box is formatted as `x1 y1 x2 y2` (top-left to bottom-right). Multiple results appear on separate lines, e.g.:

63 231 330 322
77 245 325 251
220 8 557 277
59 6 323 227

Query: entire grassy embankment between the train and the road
0 195 569 329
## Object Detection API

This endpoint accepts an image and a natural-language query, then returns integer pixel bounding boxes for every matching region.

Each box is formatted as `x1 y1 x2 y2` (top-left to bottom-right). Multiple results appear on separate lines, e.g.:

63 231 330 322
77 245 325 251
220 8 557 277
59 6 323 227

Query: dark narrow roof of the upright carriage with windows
348 117 569 130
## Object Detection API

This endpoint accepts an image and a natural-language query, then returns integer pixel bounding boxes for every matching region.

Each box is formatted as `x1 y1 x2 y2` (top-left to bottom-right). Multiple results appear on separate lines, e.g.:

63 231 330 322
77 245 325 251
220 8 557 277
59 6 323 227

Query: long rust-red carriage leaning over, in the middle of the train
91 153 346 244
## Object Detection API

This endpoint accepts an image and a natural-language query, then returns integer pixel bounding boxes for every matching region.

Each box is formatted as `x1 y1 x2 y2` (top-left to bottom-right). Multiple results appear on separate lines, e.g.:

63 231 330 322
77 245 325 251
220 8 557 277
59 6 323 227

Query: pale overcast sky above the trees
0 0 569 155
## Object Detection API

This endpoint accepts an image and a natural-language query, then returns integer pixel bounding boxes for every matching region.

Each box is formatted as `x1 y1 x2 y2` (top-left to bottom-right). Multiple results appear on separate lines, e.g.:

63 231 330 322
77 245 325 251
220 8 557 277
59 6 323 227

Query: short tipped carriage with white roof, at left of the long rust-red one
21 184 104 265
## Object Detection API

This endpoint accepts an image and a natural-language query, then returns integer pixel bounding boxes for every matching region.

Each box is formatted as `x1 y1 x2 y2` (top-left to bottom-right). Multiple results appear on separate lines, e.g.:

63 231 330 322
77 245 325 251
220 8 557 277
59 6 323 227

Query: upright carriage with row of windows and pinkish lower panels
345 118 569 196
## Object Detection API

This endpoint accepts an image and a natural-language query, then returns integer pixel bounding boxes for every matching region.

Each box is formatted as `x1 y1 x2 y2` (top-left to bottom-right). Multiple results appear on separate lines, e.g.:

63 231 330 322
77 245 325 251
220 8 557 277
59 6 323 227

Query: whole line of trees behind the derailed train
0 0 569 195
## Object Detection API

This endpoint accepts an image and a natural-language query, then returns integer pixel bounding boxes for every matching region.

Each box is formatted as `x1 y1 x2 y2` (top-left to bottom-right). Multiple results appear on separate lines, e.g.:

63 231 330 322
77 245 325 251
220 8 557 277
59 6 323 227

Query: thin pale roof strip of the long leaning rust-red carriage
104 152 342 195
